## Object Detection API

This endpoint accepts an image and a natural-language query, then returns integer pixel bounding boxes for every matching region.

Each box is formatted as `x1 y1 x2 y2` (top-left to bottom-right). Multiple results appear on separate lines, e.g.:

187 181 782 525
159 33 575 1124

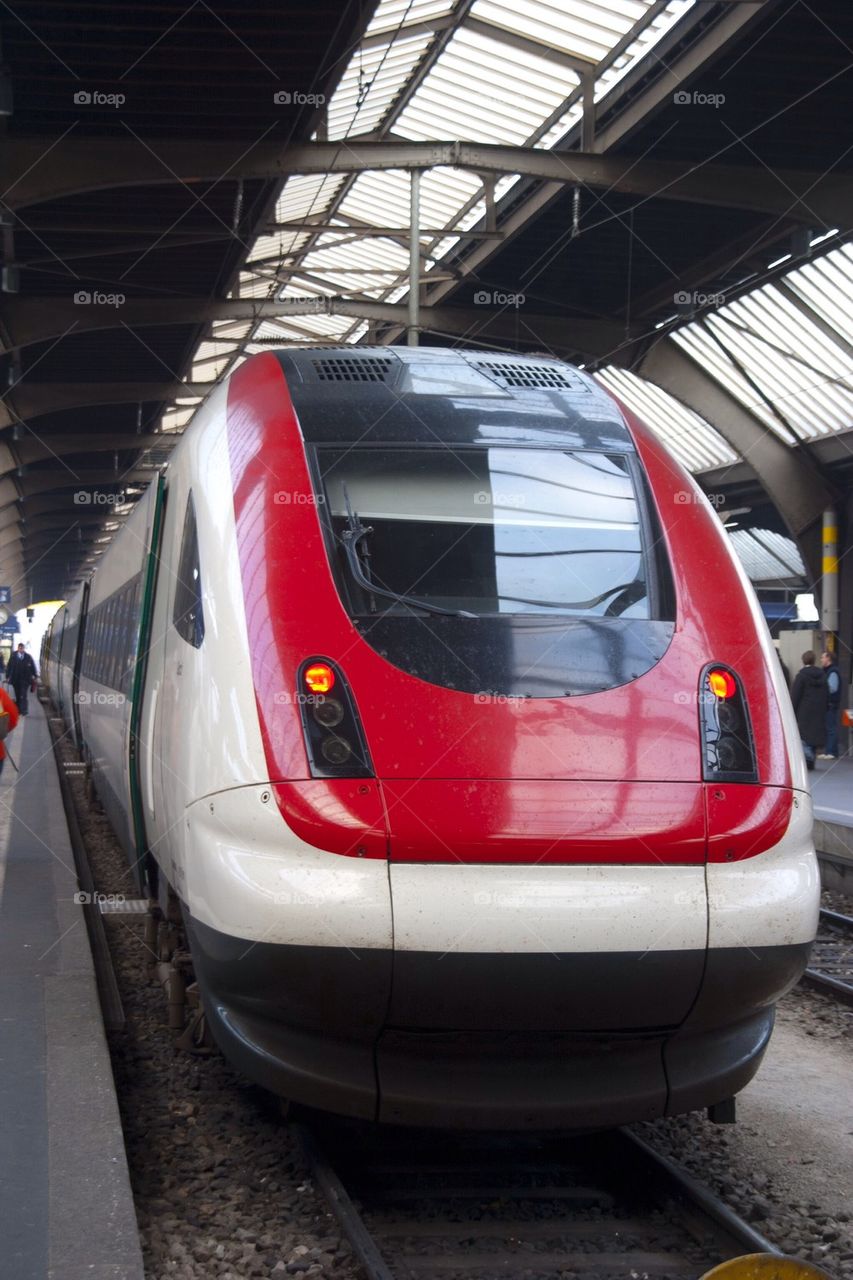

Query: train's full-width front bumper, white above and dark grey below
175 788 817 1129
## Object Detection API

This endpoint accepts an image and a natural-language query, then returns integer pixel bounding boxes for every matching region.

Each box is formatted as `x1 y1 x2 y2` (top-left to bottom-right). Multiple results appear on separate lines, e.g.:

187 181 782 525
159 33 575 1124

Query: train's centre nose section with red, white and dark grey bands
383 781 707 1032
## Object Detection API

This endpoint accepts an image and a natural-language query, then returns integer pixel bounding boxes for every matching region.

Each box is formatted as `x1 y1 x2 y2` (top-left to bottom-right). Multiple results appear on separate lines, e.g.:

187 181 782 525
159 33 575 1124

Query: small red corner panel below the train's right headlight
704 782 793 863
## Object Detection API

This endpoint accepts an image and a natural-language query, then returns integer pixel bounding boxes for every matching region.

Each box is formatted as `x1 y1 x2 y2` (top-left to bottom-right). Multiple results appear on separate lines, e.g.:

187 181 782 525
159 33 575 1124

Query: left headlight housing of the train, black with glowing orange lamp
297 658 374 778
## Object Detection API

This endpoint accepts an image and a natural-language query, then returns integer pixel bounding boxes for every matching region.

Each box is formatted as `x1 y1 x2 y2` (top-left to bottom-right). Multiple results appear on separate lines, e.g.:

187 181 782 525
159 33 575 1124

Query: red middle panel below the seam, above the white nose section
383 780 704 865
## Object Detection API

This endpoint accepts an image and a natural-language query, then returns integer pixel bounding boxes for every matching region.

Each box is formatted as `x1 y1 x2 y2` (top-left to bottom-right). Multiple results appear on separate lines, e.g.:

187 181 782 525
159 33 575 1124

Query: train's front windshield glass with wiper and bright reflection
318 447 654 618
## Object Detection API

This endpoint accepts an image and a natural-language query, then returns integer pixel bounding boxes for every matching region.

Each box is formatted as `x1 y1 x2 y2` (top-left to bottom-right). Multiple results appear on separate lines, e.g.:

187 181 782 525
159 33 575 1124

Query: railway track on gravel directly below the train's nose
297 1119 777 1280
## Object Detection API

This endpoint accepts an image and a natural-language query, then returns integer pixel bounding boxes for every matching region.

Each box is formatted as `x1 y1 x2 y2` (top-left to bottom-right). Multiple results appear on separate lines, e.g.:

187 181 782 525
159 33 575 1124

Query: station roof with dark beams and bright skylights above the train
0 0 853 603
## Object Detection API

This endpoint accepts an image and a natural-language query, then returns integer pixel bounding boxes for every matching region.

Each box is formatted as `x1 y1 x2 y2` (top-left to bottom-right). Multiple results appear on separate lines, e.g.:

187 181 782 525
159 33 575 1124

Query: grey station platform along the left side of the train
0 696 143 1280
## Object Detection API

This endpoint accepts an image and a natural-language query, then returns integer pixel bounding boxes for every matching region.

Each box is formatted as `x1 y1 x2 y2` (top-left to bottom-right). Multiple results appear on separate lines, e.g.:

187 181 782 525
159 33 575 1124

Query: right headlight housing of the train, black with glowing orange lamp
699 662 758 782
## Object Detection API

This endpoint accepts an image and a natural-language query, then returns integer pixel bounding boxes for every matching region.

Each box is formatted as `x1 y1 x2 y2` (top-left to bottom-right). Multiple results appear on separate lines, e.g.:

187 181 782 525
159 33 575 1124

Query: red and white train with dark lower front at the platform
42 347 820 1130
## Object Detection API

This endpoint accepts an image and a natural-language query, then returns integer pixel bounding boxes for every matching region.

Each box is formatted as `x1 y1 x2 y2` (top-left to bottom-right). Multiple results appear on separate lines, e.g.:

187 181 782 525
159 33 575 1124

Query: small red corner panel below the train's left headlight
274 778 388 858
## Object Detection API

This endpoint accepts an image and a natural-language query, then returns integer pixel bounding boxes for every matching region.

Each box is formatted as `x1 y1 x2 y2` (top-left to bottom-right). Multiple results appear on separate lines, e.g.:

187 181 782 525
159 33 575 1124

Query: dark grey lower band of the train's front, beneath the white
187 916 808 1129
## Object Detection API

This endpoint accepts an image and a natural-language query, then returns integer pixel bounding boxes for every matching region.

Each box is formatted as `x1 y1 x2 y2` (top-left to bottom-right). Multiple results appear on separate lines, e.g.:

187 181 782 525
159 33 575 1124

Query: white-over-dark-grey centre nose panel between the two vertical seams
388 864 707 1032
